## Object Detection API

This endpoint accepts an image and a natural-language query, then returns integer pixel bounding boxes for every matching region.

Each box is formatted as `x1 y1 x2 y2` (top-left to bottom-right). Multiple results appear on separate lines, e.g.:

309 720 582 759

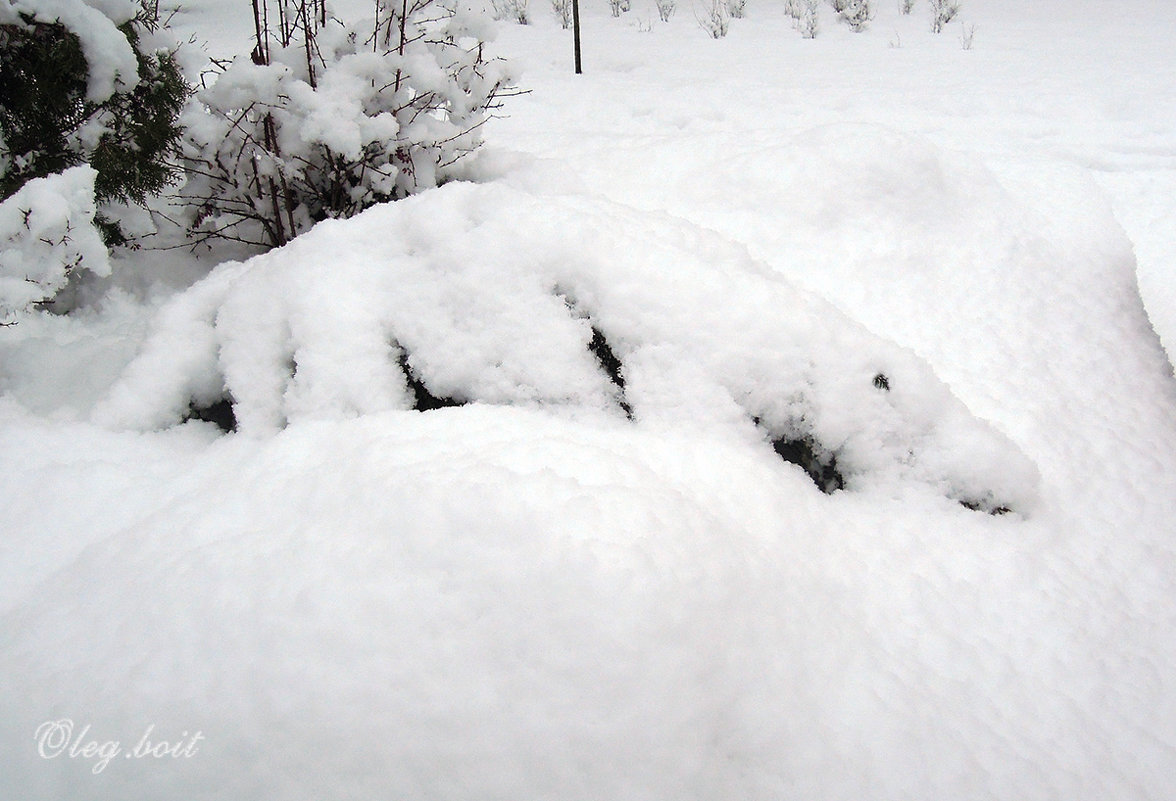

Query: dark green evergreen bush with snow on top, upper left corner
0 0 188 243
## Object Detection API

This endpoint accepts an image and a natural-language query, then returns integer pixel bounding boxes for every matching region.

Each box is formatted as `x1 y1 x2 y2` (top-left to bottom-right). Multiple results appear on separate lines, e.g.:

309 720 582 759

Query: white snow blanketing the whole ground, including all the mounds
0 0 1176 801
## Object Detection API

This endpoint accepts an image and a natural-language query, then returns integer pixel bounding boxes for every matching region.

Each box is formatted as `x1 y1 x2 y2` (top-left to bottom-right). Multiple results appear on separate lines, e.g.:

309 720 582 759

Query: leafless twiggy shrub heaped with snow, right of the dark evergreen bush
180 0 510 247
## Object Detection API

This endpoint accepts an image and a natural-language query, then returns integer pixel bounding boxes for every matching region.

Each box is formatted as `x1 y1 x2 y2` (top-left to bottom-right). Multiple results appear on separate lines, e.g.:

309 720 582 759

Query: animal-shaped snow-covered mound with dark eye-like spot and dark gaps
95 183 1037 510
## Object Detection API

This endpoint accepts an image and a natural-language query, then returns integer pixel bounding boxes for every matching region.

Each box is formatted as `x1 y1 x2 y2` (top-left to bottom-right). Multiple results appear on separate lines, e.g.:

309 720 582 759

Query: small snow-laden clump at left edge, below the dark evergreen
0 167 111 323
